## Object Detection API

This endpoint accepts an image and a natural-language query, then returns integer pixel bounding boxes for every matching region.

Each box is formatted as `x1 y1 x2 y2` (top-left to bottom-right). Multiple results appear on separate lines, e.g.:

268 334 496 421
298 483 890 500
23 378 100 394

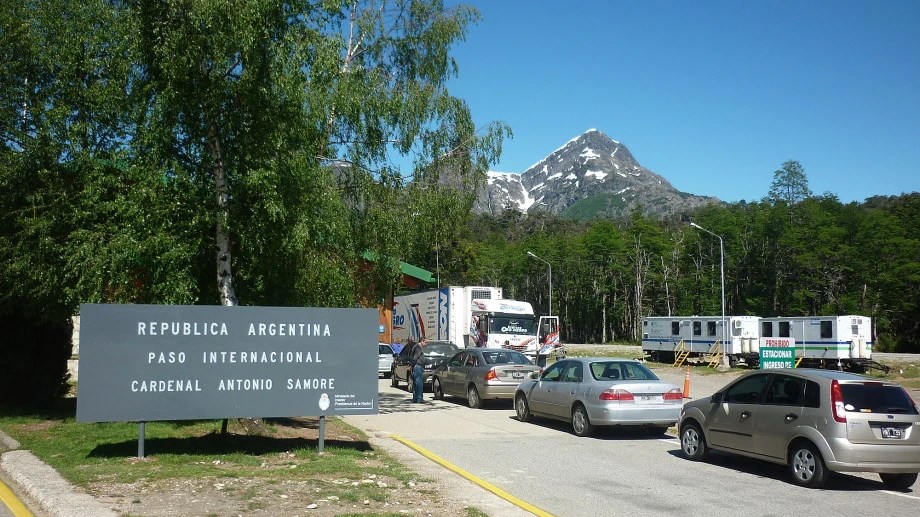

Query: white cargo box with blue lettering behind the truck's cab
392 286 502 348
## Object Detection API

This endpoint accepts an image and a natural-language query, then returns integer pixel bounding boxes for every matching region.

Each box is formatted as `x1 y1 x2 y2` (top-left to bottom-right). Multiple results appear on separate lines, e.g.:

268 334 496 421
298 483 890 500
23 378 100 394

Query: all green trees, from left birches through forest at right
0 0 920 408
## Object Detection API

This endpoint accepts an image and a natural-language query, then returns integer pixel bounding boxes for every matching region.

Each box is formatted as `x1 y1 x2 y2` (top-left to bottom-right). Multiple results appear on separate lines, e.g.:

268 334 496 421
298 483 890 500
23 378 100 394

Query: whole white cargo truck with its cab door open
393 287 564 362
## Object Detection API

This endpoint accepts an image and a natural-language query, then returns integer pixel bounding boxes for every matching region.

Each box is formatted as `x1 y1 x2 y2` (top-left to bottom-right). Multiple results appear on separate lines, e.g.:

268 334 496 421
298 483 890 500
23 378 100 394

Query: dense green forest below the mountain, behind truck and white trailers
448 190 920 352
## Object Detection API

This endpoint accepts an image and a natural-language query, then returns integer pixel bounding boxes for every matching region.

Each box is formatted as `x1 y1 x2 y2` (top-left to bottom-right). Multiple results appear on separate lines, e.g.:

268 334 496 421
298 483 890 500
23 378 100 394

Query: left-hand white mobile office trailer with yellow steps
642 316 760 365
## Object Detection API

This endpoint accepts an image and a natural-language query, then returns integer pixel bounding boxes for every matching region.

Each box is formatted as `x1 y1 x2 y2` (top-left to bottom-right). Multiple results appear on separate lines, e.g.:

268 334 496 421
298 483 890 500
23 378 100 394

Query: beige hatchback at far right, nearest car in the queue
679 368 920 489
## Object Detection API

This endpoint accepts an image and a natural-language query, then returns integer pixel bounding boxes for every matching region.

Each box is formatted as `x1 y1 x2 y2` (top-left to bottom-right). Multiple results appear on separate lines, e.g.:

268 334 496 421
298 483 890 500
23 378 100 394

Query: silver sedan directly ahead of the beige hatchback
514 357 683 436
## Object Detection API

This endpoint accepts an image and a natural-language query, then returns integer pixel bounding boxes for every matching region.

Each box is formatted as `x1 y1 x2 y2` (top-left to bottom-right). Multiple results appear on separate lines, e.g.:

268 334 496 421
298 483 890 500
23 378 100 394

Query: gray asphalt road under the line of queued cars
346 369 920 517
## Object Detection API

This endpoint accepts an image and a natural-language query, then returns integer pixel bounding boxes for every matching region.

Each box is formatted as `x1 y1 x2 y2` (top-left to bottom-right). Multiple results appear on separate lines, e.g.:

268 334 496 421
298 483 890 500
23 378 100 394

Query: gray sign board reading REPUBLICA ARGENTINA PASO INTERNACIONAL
77 304 378 422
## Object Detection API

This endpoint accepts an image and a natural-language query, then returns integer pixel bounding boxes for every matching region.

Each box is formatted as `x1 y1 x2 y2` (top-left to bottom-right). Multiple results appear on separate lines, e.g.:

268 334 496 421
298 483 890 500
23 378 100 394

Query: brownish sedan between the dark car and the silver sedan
431 348 540 408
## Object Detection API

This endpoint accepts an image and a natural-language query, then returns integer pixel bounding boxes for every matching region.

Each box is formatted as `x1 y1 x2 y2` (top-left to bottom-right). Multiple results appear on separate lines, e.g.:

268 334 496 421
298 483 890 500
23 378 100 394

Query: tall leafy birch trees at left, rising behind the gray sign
0 0 510 404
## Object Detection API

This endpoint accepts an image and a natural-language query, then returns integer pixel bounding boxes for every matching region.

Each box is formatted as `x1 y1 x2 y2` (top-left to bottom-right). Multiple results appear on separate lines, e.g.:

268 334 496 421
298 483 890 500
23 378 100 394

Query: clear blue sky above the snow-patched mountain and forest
450 0 920 203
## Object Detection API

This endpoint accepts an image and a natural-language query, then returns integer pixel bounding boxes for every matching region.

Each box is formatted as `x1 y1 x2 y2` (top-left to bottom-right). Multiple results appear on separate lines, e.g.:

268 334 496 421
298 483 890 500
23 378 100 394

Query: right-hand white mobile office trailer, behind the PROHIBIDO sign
760 315 873 371
